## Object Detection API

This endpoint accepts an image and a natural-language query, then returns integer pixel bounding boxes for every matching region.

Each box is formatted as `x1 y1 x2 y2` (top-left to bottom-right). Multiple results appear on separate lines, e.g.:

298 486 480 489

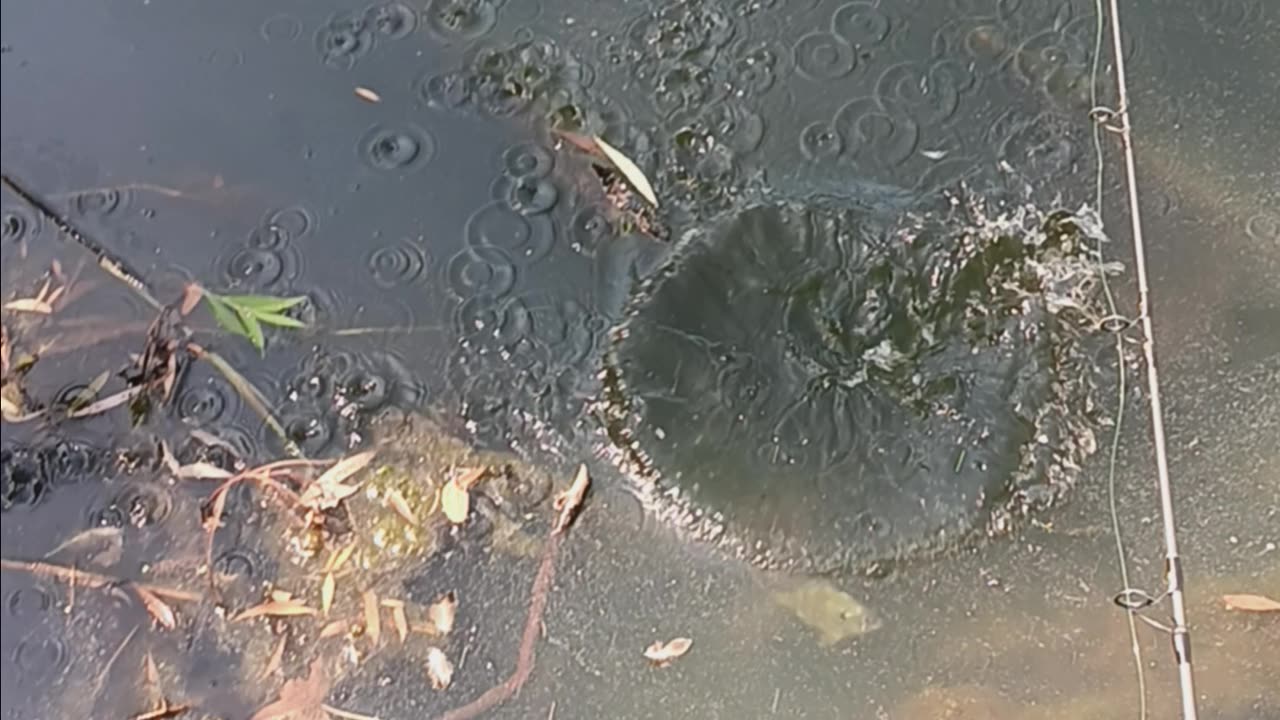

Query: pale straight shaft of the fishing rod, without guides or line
1111 0 1198 720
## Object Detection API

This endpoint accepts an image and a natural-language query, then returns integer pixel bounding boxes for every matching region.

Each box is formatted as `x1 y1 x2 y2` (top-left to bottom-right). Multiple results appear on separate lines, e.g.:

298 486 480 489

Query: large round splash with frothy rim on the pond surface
602 189 1100 571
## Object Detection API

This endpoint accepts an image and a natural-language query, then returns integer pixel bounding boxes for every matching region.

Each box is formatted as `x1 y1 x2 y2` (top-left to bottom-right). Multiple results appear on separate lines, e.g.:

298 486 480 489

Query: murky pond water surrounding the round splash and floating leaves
0 0 1280 719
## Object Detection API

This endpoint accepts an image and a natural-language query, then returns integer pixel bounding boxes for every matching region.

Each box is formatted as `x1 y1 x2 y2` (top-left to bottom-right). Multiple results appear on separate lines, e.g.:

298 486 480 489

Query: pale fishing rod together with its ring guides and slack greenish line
1089 0 1198 720
